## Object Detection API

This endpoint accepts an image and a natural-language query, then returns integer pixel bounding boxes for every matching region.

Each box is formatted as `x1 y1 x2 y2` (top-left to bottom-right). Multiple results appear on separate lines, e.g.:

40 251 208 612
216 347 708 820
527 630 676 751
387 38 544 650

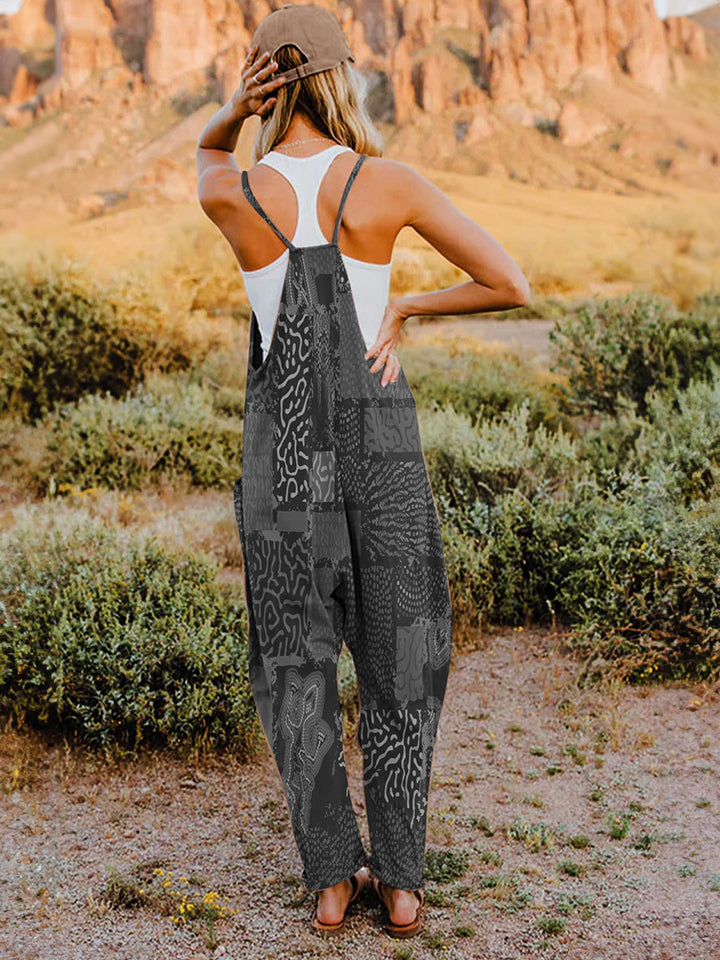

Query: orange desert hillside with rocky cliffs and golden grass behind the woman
0 0 720 301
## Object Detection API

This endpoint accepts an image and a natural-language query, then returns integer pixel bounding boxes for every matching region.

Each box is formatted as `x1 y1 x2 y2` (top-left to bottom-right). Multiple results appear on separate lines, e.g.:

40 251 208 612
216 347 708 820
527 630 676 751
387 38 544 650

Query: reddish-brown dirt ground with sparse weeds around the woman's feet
0 629 720 960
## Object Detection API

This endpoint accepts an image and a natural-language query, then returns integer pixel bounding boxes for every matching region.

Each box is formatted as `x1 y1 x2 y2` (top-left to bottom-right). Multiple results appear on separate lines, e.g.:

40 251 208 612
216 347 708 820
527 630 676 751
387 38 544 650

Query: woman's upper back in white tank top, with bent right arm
199 141 529 365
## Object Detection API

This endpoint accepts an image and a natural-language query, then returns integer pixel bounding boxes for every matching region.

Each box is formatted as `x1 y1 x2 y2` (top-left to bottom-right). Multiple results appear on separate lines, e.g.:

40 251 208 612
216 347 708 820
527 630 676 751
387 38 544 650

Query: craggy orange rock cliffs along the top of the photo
0 0 706 130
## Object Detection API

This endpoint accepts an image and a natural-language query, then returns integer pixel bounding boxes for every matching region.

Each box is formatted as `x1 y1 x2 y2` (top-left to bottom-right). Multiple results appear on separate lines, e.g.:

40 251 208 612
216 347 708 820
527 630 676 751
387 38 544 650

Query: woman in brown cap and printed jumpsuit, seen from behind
197 4 529 936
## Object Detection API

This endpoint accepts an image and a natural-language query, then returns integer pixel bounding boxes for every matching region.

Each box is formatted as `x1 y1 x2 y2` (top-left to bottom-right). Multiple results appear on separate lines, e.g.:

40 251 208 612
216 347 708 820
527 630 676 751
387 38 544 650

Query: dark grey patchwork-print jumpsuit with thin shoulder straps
233 154 451 890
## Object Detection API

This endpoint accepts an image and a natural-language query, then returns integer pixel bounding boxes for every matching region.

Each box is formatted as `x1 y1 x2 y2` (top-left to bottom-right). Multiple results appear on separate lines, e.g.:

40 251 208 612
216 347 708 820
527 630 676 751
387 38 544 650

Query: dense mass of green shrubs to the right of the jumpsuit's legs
421 394 720 680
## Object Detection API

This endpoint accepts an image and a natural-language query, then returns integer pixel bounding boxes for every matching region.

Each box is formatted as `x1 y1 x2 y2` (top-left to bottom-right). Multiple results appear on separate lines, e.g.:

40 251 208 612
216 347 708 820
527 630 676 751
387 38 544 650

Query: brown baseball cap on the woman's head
250 3 355 82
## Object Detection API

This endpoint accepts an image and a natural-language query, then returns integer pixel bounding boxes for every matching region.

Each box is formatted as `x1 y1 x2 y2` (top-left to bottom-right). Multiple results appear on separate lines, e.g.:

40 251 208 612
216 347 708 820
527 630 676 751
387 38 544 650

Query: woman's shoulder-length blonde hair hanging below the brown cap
253 44 384 163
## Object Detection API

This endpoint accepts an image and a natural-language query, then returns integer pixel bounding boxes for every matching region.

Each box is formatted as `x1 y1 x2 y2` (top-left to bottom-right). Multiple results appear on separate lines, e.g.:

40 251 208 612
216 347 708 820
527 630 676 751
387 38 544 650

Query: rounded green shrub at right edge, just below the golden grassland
549 291 720 416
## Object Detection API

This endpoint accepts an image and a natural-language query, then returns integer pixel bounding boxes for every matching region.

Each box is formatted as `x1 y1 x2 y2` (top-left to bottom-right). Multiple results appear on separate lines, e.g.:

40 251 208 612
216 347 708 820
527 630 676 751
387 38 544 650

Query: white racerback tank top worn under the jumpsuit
240 144 392 358
